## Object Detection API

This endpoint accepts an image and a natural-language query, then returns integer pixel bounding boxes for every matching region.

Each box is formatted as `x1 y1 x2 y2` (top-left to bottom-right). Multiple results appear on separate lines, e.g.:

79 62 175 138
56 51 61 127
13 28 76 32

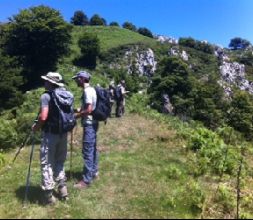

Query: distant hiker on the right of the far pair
115 80 126 117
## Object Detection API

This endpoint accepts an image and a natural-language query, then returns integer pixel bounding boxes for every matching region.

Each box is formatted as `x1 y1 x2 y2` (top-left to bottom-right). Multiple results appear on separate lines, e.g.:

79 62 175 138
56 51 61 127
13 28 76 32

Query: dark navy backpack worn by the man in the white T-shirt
92 86 111 121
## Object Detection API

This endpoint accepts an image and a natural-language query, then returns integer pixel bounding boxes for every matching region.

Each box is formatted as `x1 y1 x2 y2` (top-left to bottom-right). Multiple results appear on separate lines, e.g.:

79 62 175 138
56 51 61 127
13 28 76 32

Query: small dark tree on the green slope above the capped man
77 33 100 69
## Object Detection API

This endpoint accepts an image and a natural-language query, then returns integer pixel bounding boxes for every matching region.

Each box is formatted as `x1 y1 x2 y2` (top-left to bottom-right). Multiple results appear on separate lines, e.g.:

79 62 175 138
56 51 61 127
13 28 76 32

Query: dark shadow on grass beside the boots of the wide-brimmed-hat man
16 186 43 205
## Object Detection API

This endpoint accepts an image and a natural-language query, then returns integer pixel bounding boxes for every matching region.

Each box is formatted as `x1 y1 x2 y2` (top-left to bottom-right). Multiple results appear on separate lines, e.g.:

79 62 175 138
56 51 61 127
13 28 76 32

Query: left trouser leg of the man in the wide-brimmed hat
40 132 56 190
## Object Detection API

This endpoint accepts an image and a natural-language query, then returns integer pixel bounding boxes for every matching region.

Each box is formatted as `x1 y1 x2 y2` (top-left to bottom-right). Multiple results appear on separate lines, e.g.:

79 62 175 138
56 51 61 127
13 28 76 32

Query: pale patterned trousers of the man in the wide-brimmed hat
40 132 67 190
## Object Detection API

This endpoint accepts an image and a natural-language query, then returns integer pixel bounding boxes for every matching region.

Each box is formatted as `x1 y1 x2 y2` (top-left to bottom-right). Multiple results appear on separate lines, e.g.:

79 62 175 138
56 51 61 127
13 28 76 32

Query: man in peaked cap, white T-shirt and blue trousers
72 71 98 189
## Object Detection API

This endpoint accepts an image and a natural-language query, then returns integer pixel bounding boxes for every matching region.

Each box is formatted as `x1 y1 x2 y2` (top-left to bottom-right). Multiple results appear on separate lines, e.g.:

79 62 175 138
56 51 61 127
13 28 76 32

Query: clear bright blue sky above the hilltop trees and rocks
0 0 253 47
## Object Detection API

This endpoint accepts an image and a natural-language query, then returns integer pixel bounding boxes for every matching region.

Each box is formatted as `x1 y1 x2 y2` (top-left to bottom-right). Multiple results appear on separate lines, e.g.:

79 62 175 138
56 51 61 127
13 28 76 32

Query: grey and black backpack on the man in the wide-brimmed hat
51 88 76 133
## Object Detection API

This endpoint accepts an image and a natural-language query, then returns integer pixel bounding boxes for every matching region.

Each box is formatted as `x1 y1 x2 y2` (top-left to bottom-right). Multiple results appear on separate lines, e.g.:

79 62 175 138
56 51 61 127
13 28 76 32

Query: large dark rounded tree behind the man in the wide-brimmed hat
4 6 71 89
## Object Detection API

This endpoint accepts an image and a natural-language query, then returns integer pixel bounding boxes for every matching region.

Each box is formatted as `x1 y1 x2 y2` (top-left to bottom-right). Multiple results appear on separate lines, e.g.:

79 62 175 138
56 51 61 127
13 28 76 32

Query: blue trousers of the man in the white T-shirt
82 125 96 184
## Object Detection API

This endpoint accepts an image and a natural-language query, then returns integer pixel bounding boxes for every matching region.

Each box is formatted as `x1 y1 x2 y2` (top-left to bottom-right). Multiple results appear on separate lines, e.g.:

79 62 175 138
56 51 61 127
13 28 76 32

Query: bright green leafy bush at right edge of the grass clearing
187 128 238 175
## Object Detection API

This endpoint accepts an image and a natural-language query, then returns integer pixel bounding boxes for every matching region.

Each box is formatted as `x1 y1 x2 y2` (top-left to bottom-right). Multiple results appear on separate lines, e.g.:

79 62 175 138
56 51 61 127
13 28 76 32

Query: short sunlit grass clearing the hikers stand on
0 114 199 218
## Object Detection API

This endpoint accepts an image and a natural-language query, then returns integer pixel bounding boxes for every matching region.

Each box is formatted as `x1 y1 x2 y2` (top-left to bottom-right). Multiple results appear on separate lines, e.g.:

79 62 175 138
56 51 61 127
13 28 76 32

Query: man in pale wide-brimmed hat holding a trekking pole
32 72 68 204
